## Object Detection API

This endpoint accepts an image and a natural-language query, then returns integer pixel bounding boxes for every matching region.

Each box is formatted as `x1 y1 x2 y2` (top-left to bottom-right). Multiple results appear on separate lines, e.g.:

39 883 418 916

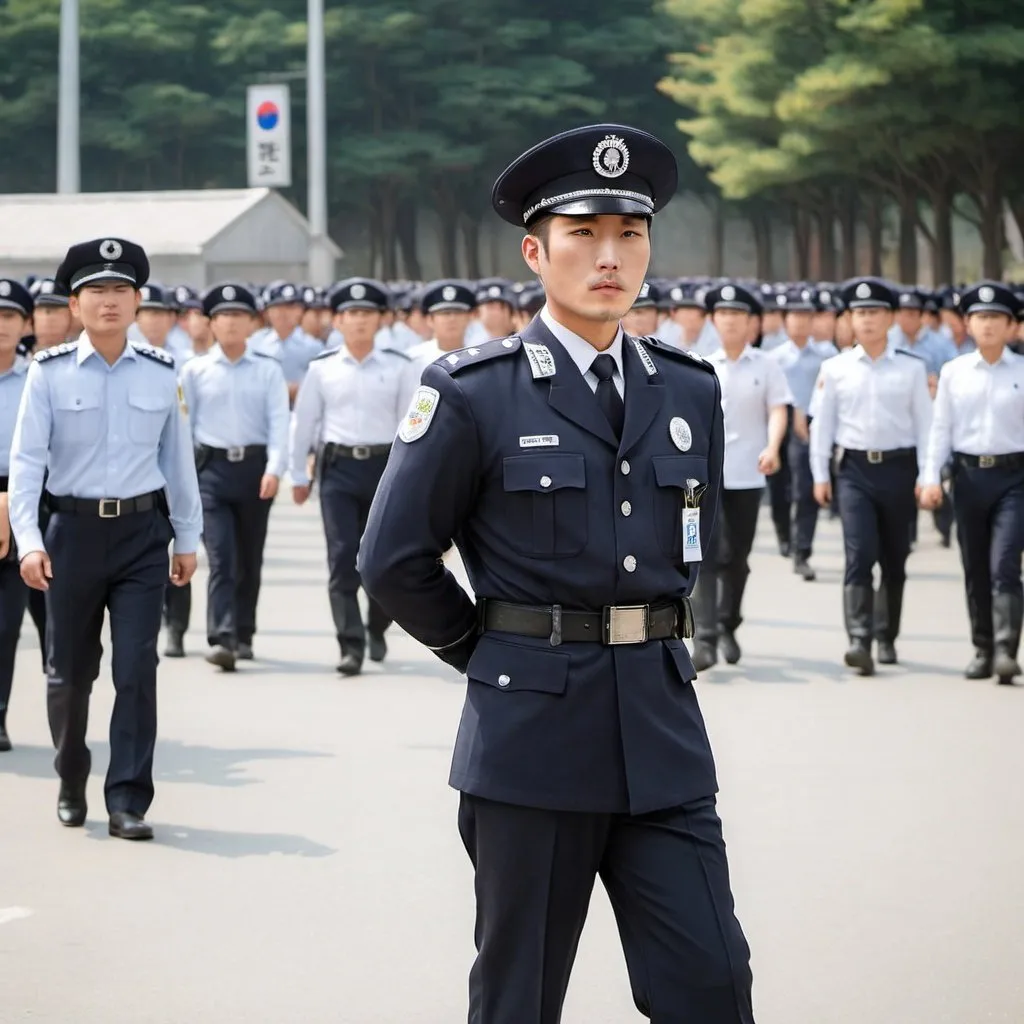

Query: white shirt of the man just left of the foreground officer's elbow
289 346 422 484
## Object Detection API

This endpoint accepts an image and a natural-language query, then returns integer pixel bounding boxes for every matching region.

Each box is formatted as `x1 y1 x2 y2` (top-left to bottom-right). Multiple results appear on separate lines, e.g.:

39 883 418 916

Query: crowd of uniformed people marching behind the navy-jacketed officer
0 239 1024 838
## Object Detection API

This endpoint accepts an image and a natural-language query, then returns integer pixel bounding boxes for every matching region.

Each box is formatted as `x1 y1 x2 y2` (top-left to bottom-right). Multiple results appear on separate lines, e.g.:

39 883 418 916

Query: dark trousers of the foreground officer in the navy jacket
459 794 754 1024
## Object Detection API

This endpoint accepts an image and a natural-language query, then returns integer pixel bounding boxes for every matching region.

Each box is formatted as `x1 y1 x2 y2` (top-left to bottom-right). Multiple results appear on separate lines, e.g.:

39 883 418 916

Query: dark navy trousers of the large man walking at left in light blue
45 509 173 814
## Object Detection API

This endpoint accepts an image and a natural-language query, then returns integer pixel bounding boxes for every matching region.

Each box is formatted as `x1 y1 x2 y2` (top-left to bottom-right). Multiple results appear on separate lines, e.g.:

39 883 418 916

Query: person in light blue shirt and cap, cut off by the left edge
0 278 33 753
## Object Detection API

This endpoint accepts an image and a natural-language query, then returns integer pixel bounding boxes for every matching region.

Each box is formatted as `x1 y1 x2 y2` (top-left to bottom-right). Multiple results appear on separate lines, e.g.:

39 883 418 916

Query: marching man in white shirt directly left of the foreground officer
289 278 419 676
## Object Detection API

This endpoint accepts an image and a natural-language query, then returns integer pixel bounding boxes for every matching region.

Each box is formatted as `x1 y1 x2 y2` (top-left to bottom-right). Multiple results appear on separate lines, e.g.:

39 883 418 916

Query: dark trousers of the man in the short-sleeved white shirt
693 487 771 643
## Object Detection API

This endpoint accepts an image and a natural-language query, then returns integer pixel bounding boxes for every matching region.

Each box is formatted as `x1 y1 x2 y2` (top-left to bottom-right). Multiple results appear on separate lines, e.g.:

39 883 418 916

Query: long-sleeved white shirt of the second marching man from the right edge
811 345 932 483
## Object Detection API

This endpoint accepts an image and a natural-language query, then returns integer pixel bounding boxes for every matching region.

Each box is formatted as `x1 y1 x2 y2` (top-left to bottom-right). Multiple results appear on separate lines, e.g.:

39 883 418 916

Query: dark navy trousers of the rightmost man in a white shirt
953 465 1024 651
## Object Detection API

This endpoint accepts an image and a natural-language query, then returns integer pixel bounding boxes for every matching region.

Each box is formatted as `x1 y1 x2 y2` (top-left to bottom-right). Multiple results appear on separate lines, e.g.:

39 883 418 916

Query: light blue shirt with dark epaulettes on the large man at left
9 334 203 555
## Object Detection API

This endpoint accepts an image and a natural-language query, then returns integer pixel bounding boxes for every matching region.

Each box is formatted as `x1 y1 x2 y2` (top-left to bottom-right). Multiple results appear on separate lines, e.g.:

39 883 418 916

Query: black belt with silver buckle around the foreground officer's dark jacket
477 597 693 647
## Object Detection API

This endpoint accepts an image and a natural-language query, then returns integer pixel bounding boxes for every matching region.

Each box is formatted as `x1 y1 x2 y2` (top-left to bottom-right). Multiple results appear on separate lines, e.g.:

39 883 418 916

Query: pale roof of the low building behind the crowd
0 188 341 262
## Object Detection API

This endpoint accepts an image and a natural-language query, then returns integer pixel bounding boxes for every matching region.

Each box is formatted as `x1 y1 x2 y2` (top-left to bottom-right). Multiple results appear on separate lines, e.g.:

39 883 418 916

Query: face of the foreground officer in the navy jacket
522 214 650 329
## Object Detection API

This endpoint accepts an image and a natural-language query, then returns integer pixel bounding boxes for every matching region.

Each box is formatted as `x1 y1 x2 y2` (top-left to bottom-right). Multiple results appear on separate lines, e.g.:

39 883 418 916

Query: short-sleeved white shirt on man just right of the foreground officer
708 345 793 490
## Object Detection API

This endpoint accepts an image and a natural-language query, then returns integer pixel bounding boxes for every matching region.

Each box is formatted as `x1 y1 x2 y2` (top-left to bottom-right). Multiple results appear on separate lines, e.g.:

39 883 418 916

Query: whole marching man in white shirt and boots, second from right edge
810 278 932 676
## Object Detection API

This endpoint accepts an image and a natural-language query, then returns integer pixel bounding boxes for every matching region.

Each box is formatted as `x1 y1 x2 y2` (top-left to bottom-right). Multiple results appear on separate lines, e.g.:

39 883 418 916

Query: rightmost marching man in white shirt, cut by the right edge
921 281 1024 684
